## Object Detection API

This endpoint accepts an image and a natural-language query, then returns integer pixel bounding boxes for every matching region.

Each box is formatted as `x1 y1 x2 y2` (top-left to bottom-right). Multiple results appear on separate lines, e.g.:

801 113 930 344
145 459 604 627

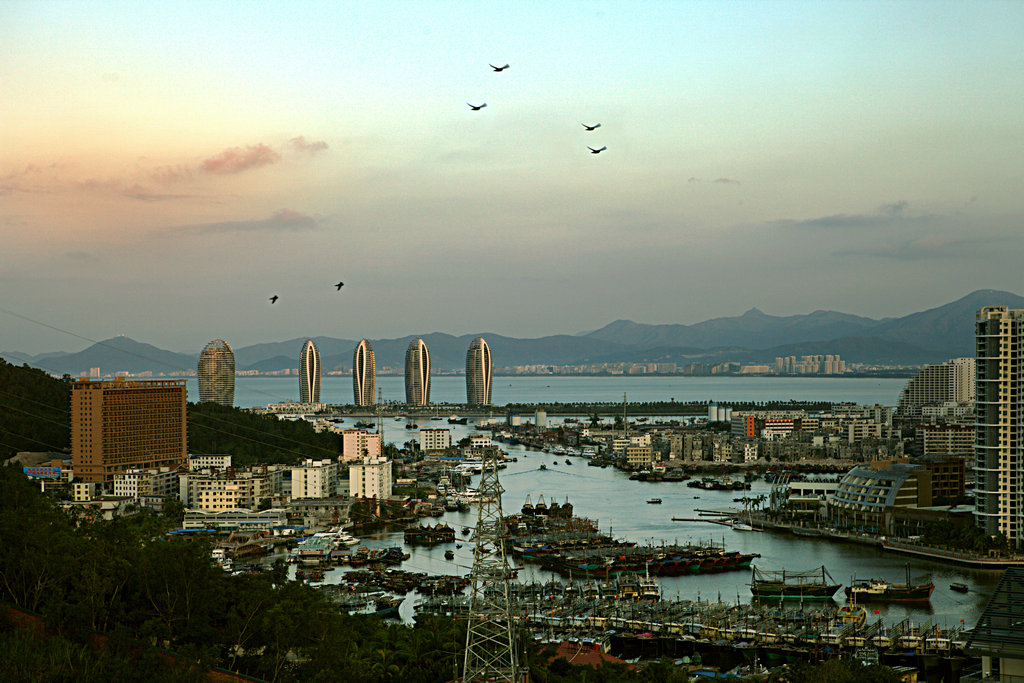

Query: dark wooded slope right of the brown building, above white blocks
188 403 341 466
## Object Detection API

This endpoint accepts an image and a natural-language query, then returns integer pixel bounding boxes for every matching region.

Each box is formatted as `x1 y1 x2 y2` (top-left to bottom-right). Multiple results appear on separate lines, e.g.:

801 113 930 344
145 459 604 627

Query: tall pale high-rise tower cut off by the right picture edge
974 306 1024 548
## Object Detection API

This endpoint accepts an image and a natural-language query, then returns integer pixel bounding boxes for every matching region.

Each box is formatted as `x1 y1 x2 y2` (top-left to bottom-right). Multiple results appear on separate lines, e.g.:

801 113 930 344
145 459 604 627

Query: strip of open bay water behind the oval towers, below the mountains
185 375 907 410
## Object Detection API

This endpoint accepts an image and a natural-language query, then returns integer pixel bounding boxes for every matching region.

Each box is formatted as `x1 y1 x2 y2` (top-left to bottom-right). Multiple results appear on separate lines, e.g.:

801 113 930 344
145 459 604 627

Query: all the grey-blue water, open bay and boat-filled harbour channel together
228 376 1001 629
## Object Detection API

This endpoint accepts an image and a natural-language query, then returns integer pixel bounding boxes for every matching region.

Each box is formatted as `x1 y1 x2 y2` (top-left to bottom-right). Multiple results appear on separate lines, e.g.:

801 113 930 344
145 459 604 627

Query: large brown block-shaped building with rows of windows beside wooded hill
71 377 187 483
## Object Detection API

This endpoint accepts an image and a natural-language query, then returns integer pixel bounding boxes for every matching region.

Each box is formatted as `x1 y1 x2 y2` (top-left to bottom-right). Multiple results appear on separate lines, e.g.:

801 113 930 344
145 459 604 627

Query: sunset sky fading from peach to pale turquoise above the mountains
0 0 1024 353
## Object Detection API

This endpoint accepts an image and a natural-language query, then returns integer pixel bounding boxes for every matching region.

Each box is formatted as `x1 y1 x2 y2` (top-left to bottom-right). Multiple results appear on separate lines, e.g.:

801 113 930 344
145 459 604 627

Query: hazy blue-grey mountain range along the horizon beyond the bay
0 290 1024 375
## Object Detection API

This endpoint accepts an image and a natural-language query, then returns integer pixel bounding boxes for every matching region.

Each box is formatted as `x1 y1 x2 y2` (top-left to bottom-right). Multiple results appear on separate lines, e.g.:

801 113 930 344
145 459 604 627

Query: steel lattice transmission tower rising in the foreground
462 449 526 683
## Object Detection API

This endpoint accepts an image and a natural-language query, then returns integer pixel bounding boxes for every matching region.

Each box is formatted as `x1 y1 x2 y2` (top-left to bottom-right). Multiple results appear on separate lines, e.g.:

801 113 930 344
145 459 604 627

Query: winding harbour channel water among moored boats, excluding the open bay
292 422 1001 628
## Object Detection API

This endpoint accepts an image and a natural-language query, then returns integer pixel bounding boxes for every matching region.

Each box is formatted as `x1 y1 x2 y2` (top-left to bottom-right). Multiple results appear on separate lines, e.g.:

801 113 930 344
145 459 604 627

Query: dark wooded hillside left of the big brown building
0 359 71 462
